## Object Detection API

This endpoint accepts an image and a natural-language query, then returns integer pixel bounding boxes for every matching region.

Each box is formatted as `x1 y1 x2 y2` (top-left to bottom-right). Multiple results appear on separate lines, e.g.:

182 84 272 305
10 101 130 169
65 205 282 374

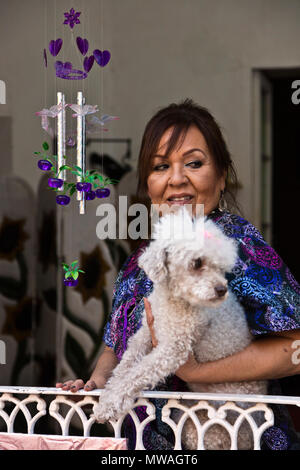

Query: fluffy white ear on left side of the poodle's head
138 241 168 282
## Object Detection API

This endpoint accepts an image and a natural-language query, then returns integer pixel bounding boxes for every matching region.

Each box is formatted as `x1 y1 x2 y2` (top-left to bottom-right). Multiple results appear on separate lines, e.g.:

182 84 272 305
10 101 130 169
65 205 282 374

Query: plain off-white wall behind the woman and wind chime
0 0 300 220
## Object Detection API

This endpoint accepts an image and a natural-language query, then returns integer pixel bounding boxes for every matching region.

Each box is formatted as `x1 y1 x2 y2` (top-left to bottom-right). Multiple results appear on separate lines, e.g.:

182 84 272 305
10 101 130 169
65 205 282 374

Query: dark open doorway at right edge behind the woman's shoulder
264 69 300 431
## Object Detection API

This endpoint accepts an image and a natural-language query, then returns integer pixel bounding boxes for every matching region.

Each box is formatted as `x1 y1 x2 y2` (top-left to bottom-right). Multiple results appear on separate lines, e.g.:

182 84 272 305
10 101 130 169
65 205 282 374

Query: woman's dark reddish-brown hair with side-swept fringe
137 98 240 212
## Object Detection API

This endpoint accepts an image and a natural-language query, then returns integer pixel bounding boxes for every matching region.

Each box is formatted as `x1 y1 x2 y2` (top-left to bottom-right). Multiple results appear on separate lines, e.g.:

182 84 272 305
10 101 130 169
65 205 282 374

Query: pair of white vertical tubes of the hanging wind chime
57 91 86 214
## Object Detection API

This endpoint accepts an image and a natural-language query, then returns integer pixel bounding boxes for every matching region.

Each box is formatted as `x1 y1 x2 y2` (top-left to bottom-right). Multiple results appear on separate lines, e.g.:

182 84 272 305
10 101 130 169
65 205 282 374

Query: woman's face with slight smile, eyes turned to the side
147 125 225 215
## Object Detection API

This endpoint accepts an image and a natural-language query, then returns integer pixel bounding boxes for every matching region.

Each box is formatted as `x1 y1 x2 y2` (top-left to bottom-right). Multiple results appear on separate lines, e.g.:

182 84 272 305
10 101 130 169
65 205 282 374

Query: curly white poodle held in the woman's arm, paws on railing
94 207 267 449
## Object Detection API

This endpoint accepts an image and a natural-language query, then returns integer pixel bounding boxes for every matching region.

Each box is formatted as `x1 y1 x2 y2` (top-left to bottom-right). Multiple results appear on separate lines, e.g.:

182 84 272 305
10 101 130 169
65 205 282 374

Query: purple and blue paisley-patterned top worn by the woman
104 209 300 450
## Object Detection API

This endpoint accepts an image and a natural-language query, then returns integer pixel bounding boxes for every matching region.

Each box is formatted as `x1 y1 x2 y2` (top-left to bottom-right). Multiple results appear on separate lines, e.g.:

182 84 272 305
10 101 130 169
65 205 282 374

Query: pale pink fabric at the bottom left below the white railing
0 432 127 450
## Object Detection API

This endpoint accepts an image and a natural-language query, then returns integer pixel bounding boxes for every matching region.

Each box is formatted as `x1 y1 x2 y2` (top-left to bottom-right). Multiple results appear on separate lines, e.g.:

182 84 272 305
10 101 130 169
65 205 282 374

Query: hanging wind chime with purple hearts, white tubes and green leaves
34 8 119 286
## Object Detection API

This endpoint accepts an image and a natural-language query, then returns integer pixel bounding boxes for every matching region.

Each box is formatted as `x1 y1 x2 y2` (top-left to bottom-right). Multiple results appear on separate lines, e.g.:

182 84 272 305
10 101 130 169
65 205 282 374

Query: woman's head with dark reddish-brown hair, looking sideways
137 99 238 218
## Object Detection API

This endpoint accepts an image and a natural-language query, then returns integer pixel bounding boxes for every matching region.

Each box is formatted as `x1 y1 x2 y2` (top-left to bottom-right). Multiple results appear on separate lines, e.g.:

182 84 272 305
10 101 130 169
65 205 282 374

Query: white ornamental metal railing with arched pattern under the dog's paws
0 386 300 450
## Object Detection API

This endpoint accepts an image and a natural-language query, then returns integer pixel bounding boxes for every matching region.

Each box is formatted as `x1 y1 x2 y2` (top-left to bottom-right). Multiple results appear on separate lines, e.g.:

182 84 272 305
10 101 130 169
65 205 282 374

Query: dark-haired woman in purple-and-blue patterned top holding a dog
56 100 300 450
